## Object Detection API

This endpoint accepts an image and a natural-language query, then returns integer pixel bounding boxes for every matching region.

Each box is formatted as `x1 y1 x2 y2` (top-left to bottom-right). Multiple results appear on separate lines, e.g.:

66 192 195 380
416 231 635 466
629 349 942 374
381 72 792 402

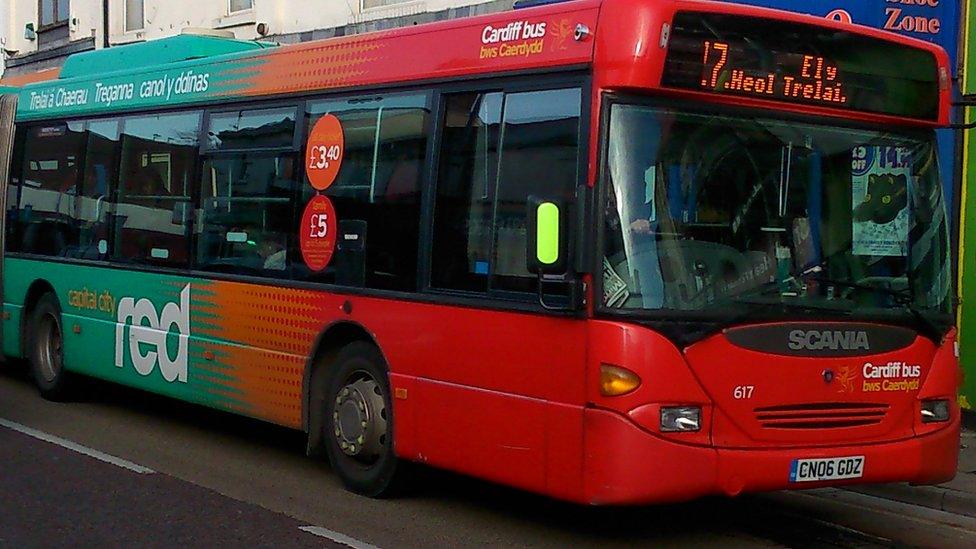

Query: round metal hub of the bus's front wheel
332 377 387 461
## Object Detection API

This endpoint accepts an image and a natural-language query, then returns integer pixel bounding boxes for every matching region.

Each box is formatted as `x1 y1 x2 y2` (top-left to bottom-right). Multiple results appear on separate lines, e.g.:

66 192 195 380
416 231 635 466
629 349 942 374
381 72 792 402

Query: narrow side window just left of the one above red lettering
76 120 119 259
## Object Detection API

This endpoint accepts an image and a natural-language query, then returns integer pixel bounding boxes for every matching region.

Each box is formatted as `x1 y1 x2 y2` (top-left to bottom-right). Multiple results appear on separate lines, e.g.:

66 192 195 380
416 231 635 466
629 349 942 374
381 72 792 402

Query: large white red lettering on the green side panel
115 284 190 383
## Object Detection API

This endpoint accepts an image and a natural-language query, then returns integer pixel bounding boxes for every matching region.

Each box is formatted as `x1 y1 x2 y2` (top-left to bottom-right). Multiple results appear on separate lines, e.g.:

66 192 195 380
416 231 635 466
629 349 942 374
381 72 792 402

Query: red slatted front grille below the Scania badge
753 402 888 429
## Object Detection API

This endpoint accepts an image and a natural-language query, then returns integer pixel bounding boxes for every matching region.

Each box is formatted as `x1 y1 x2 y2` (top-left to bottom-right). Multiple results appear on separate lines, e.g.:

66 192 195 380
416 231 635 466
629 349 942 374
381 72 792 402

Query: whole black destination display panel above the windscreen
661 12 939 120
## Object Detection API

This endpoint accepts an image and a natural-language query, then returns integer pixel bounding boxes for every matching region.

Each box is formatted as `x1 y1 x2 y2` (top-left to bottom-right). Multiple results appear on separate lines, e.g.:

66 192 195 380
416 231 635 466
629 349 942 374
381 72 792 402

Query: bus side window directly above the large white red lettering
114 112 200 266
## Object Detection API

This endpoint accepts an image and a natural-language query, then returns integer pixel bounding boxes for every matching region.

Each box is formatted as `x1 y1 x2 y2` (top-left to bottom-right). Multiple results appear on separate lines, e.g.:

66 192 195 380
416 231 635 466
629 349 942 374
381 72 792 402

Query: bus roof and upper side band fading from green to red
11 0 944 119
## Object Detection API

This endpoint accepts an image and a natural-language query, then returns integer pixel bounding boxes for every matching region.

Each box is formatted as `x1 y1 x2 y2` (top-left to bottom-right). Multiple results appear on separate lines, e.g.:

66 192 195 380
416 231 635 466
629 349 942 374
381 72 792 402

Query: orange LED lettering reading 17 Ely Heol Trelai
700 40 848 106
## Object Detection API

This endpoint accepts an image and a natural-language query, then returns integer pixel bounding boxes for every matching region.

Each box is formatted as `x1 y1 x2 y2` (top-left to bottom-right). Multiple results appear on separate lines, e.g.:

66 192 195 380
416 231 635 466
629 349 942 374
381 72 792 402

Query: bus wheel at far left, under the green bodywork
28 294 71 400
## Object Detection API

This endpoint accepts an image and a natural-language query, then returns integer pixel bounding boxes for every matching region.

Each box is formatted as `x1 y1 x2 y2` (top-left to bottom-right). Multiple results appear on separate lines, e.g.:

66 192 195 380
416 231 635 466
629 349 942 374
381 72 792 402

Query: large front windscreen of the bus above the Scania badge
602 103 950 324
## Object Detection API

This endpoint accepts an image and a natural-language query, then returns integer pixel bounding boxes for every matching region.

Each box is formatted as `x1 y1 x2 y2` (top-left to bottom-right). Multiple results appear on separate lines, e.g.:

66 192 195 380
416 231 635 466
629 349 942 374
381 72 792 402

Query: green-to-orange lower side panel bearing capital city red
3 257 306 427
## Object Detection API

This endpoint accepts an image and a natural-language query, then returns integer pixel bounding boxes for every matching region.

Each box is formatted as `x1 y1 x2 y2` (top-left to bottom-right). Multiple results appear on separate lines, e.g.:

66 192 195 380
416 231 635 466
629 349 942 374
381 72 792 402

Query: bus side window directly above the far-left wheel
17 122 85 256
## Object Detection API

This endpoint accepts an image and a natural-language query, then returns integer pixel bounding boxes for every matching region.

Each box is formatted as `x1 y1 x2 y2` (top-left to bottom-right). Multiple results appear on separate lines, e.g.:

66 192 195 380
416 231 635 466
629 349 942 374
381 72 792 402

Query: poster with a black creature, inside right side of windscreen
851 146 912 256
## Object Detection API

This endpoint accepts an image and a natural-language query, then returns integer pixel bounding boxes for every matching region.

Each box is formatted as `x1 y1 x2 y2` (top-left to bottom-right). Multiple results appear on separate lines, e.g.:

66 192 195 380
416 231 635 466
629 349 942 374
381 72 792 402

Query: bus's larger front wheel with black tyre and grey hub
322 341 403 497
